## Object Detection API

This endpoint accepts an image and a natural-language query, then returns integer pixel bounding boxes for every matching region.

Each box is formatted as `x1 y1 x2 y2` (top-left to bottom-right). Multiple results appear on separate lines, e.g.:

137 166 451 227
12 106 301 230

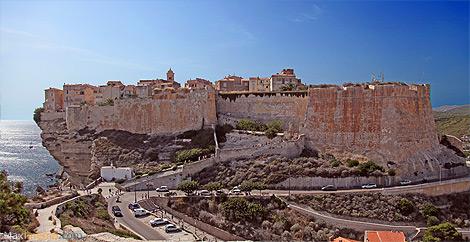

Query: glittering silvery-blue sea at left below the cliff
0 120 60 197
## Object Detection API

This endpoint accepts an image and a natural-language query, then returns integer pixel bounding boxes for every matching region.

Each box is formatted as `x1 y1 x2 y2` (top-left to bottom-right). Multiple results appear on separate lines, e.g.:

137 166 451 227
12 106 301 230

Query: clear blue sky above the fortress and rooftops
0 0 470 119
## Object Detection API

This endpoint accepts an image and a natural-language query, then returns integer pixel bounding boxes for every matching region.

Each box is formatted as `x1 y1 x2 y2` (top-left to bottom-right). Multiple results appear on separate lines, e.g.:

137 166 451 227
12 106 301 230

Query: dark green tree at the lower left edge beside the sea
0 170 30 232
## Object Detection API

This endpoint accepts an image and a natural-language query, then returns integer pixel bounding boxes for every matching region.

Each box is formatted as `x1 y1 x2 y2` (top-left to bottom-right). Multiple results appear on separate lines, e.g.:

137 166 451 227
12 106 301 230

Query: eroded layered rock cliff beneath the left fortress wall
38 113 188 185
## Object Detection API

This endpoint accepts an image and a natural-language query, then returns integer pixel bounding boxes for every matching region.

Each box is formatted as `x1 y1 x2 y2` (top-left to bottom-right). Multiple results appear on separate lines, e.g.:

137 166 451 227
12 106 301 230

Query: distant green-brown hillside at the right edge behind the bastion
433 105 470 138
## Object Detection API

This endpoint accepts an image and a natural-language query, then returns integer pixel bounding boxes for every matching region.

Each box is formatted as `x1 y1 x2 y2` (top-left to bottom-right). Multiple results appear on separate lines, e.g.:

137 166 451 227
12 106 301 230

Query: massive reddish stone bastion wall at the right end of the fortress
303 84 438 165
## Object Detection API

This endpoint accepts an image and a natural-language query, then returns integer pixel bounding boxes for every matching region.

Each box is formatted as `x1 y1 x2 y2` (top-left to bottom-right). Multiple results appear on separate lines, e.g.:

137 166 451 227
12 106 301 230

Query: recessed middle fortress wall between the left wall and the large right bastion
216 91 308 131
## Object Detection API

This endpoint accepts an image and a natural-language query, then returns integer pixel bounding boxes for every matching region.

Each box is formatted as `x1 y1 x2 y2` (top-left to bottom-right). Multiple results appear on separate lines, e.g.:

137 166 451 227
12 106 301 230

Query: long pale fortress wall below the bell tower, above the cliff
67 90 216 134
